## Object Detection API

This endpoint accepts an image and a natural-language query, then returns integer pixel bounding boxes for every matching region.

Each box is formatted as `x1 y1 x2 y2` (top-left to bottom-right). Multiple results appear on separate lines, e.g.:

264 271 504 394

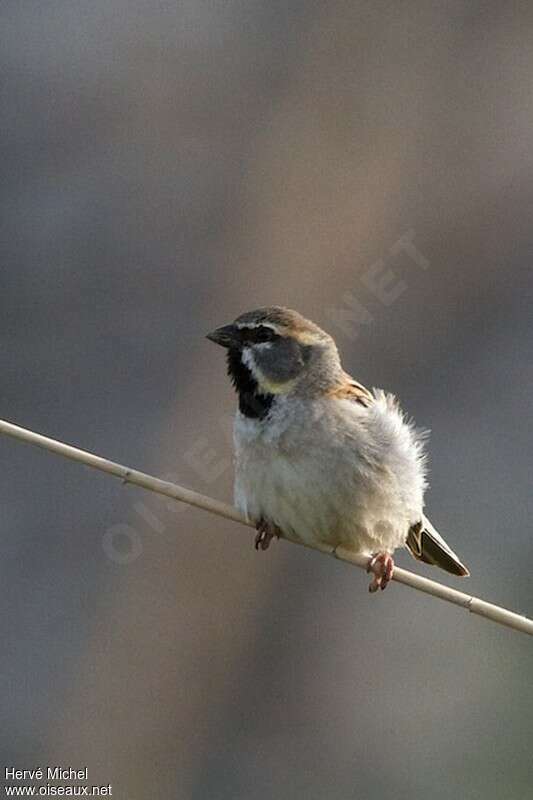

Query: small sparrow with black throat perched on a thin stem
207 306 469 592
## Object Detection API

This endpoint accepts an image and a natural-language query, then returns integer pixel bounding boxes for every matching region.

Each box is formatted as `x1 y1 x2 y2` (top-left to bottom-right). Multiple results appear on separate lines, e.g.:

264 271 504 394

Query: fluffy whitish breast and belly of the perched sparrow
235 395 425 553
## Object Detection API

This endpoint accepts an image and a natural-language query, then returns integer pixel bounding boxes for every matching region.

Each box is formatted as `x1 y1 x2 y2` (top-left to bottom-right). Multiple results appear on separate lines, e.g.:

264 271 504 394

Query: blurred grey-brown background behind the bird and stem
0 0 533 800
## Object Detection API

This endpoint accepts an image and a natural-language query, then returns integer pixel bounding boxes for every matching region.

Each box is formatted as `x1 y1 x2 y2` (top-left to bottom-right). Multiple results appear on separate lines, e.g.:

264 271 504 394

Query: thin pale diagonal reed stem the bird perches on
0 420 533 635
